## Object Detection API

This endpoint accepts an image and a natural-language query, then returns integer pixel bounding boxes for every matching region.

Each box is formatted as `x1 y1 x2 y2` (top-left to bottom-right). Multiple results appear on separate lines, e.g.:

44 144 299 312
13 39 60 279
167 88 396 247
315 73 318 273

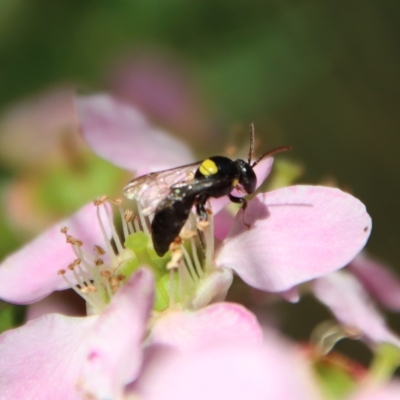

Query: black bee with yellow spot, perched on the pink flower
124 124 290 257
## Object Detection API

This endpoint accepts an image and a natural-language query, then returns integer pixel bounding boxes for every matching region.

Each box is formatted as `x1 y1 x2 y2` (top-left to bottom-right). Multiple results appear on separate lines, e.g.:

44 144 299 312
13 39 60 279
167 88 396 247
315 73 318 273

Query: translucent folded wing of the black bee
124 161 201 215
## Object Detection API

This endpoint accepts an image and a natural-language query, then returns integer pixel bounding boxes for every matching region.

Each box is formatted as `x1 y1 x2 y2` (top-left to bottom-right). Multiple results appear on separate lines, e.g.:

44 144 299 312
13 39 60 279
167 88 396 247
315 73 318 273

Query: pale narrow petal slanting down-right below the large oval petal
312 271 400 347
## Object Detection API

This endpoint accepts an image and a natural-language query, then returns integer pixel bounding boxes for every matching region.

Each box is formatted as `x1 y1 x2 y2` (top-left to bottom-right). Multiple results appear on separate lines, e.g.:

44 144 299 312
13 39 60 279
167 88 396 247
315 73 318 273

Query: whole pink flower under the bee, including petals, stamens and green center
0 96 371 399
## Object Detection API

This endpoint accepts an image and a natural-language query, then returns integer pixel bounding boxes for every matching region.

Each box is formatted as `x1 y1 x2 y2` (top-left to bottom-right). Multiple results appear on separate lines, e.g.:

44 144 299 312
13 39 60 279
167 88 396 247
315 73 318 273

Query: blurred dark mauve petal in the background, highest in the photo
110 52 211 144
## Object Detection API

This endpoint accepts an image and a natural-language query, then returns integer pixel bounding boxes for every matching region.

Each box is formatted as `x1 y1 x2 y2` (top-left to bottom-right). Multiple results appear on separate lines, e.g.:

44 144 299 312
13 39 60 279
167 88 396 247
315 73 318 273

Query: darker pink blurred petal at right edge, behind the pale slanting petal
349 253 400 311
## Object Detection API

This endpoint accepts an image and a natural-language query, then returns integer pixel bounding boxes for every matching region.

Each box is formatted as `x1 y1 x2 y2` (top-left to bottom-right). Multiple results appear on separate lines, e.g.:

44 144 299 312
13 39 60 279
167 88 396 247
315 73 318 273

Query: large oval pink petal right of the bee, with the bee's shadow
216 186 372 292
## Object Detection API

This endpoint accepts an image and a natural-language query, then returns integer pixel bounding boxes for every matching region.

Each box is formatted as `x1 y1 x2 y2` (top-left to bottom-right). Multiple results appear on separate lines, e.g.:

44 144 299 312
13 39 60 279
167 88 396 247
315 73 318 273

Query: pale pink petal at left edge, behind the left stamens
0 203 110 304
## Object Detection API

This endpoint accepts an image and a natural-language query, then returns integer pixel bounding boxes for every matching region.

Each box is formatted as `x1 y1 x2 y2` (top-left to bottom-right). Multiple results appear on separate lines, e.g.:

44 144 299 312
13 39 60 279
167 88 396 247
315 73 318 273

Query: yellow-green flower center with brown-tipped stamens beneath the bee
59 197 232 314
